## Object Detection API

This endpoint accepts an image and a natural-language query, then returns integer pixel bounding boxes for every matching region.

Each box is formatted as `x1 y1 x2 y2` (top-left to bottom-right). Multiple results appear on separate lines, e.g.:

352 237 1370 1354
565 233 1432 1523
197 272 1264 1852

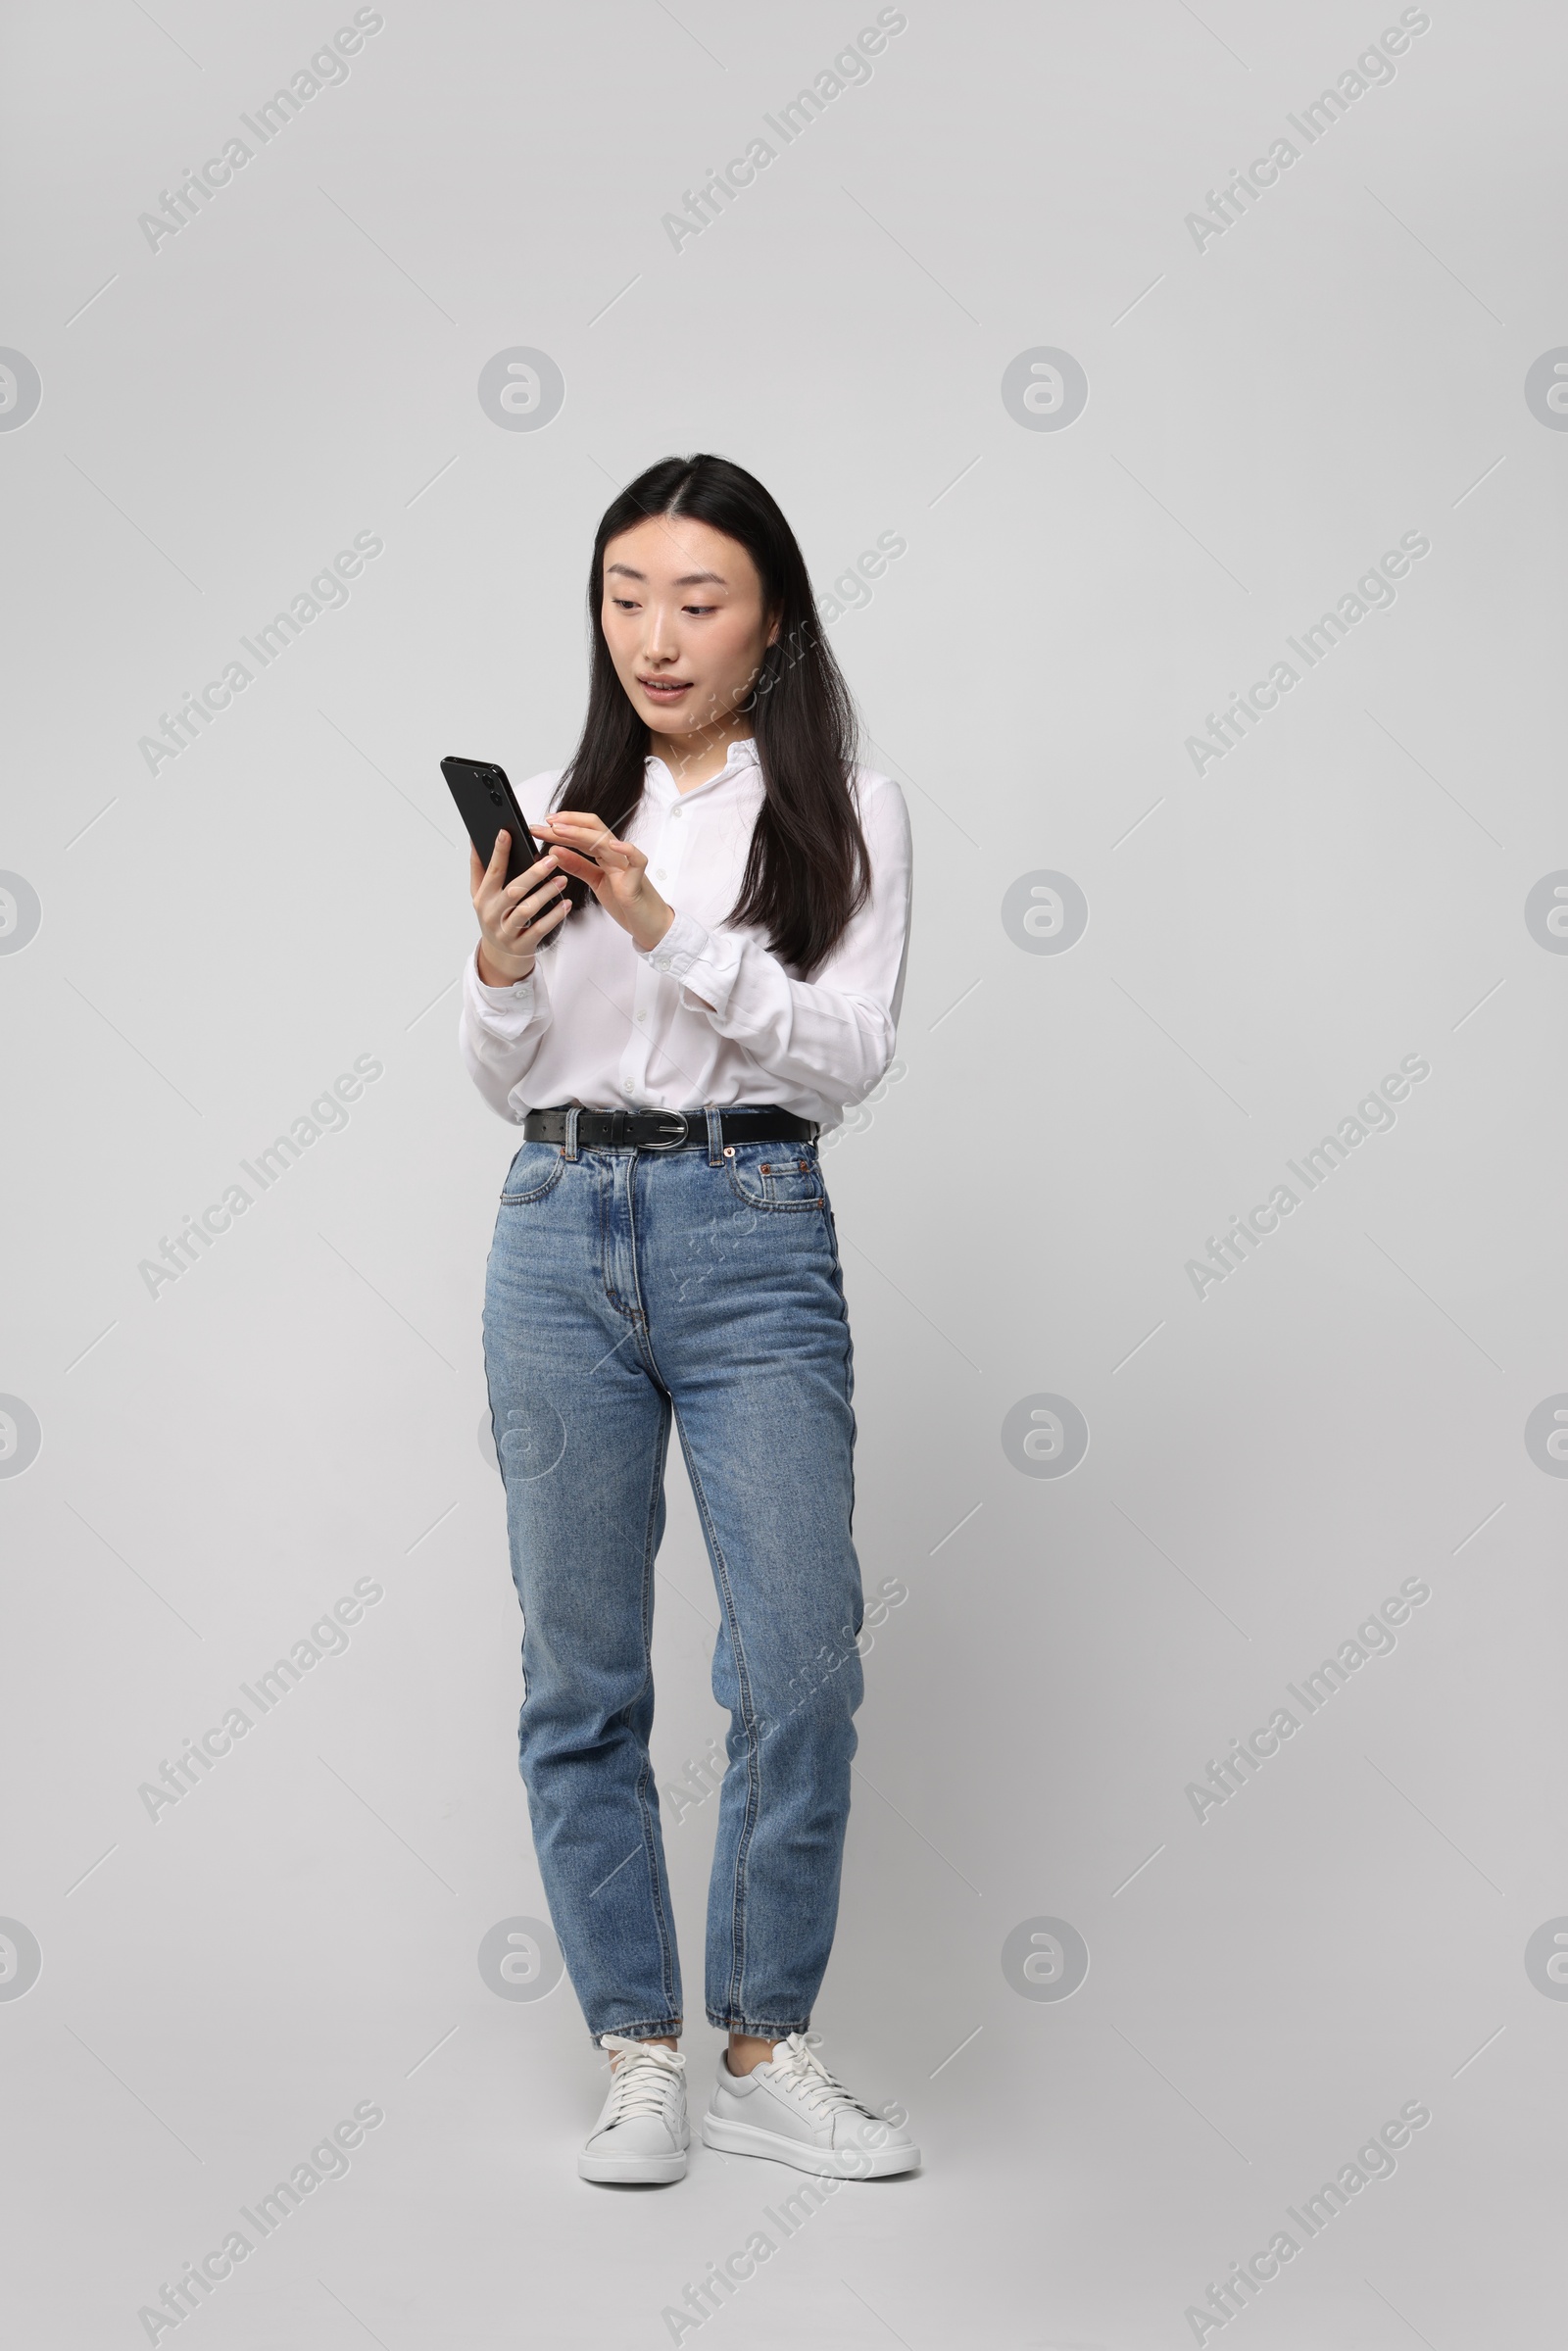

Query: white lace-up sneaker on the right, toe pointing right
703 2033 919 2180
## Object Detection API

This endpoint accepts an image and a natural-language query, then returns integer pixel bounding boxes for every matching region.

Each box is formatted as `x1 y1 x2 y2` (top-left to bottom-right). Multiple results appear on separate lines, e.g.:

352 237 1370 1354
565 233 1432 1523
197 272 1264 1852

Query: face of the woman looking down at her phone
602 514 778 736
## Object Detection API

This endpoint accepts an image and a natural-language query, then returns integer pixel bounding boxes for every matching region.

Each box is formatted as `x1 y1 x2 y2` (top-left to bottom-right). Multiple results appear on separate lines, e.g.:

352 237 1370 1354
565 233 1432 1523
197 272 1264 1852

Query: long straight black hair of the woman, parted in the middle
555 456 870 978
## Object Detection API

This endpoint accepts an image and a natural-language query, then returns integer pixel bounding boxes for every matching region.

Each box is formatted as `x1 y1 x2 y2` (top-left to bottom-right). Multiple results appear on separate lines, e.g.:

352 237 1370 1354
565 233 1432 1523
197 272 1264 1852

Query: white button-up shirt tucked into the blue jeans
459 738 909 1129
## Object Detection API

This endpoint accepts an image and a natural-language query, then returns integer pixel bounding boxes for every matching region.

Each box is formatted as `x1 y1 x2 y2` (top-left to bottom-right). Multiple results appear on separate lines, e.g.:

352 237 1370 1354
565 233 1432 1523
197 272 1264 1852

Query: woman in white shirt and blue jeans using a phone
461 456 919 2181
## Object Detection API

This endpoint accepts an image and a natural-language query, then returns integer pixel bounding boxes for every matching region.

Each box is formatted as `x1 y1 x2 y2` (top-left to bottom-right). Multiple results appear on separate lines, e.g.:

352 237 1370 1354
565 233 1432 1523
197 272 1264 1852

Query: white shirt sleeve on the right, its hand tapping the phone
642 776 912 1102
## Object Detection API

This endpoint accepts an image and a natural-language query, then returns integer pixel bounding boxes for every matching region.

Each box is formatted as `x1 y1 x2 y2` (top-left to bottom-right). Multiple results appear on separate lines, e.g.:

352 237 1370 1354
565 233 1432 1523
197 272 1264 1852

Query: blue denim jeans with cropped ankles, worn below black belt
484 1112 862 2038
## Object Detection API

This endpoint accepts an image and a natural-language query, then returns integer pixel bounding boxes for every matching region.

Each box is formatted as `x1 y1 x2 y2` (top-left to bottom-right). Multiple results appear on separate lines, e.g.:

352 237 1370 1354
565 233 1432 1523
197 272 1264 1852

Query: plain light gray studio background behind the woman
0 0 1568 2351
